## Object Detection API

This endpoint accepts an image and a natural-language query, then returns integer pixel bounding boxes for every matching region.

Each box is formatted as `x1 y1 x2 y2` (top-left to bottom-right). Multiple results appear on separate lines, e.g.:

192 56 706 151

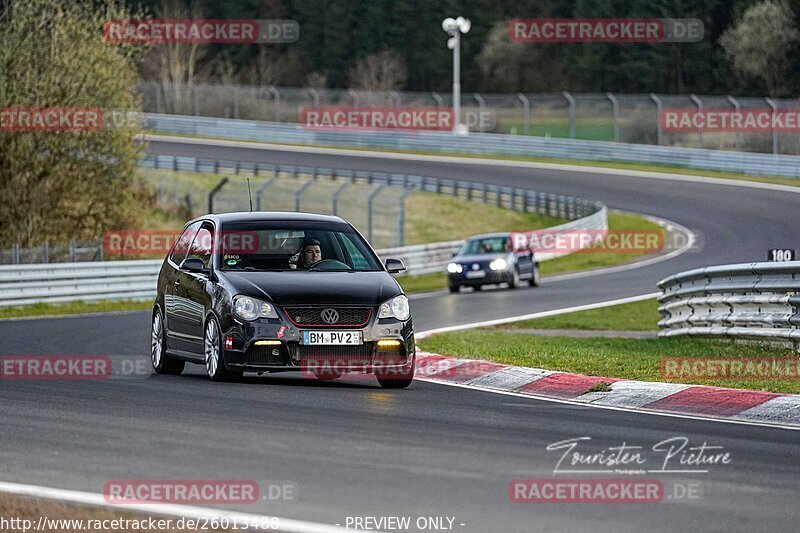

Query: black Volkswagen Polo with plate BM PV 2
151 212 414 388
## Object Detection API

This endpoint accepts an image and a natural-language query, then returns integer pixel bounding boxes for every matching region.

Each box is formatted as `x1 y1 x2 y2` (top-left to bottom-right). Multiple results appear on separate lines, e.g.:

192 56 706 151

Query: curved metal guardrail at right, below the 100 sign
658 261 800 342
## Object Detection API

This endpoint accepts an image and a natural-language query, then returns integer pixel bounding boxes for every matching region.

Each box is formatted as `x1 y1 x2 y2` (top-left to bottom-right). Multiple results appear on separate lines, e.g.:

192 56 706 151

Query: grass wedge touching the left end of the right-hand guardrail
496 299 661 331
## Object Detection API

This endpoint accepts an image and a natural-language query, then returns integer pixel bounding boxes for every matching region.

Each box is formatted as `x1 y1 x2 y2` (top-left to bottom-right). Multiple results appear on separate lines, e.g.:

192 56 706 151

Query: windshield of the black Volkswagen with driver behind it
217 221 383 272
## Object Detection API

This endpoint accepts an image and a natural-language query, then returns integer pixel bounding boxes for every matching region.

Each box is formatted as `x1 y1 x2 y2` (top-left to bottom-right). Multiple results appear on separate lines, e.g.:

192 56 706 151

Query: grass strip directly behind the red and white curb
418 329 800 393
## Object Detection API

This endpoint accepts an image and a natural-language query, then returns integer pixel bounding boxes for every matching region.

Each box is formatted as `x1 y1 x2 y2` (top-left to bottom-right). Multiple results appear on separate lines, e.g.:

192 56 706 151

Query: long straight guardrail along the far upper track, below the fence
143 113 800 178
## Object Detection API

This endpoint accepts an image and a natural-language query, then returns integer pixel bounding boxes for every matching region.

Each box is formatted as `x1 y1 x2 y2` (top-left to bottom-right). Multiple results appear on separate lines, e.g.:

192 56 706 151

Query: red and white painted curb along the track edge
415 350 800 428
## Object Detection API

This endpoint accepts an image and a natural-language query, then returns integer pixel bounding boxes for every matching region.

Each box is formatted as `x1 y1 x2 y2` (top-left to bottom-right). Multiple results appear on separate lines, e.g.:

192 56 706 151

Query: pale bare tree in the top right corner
719 0 800 96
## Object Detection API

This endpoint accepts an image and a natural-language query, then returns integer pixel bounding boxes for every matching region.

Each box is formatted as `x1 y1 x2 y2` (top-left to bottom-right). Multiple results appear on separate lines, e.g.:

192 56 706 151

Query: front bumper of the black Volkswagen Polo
223 312 415 373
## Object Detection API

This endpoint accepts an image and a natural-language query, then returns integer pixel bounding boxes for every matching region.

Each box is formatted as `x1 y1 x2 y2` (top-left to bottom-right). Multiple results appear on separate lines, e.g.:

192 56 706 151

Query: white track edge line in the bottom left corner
0 481 356 533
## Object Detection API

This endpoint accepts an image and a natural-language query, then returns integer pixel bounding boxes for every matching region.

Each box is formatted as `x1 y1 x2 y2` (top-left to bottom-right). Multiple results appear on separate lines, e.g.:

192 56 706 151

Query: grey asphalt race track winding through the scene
0 142 800 531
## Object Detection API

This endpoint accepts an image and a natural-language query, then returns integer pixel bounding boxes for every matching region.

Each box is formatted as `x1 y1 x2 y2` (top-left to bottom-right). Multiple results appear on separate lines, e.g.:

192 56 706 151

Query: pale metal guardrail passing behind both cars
0 209 608 307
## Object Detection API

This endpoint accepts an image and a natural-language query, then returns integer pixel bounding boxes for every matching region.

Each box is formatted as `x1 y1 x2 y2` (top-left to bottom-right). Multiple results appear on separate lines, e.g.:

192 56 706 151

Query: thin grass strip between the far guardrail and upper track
149 132 800 187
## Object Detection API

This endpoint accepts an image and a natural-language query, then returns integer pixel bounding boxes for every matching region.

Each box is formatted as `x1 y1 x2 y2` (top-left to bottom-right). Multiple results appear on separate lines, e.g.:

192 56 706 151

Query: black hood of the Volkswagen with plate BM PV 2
219 271 401 305
